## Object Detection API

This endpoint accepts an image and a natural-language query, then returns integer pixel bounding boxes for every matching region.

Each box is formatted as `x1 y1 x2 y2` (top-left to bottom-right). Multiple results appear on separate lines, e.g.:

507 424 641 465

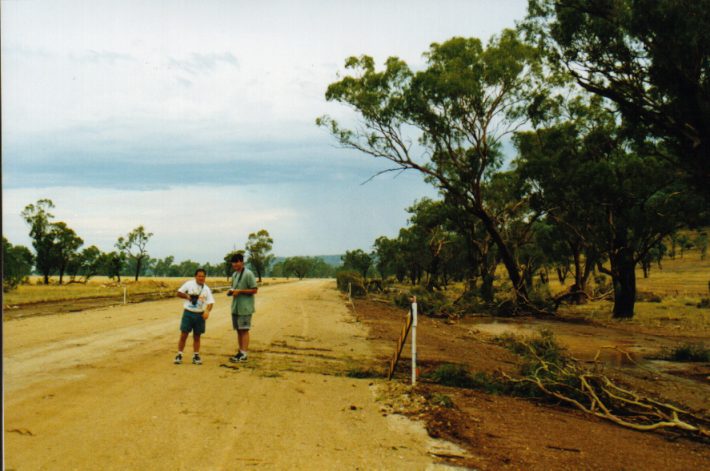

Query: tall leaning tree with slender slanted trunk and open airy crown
316 30 539 303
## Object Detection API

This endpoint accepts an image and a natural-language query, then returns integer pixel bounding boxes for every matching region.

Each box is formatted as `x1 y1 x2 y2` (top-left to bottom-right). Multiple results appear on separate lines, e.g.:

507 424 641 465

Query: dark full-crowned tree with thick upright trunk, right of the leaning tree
516 97 707 318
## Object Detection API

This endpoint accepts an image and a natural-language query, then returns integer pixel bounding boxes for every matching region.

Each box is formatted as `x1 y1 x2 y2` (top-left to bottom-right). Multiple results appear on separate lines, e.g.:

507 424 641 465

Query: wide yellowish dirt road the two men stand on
3 280 462 470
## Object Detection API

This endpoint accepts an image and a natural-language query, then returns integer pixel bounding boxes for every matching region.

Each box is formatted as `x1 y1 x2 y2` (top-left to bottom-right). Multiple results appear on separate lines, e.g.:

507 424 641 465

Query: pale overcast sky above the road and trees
0 0 527 263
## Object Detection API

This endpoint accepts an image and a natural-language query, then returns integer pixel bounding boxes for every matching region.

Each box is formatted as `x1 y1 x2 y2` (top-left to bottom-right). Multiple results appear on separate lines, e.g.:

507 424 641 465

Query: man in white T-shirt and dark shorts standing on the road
174 268 214 365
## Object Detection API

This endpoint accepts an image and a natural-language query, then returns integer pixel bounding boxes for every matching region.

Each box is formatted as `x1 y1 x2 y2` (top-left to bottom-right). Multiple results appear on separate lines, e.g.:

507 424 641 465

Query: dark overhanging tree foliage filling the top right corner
523 0 710 197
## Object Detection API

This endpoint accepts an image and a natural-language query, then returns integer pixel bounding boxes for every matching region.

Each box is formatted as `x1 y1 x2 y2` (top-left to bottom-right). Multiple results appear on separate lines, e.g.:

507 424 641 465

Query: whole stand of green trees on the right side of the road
316 0 710 318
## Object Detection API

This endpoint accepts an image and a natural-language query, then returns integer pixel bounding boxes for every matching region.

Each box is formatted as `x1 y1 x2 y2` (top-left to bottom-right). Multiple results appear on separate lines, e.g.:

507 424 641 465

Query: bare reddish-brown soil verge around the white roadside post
355 300 710 470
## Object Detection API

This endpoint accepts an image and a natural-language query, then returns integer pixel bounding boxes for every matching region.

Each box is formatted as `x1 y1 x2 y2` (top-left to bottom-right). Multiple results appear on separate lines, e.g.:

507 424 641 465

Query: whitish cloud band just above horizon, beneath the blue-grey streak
3 174 435 262
